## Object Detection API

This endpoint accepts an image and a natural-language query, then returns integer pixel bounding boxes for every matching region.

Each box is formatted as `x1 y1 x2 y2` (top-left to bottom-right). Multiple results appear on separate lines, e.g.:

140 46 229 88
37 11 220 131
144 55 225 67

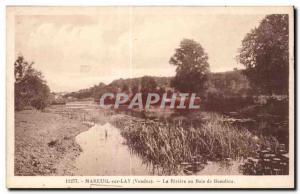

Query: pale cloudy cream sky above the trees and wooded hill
15 8 265 92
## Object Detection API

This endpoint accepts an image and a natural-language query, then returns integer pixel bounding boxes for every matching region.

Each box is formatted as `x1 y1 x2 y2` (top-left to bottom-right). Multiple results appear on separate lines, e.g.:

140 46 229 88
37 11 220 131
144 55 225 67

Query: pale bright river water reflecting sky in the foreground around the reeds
74 123 240 176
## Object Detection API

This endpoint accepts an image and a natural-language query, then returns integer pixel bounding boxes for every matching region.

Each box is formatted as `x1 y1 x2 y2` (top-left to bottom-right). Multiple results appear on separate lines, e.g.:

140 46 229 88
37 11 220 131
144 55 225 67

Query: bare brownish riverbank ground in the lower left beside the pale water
15 110 89 176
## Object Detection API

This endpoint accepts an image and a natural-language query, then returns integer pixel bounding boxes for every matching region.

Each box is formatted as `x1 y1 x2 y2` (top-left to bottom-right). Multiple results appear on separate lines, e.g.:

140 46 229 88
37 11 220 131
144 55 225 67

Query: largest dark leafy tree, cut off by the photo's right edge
238 14 289 94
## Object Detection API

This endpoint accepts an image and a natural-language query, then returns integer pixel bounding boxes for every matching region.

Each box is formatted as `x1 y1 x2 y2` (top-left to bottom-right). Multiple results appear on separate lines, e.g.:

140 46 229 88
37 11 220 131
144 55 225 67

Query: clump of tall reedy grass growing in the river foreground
114 114 276 174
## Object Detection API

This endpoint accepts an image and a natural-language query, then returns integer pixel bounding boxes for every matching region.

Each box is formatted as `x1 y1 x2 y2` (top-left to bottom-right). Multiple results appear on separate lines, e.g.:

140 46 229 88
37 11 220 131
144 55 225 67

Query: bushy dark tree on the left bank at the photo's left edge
14 56 50 110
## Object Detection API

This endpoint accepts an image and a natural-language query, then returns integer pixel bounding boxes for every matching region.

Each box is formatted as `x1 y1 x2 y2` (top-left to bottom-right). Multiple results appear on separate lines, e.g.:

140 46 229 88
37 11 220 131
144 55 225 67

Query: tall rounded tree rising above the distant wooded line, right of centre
169 39 209 93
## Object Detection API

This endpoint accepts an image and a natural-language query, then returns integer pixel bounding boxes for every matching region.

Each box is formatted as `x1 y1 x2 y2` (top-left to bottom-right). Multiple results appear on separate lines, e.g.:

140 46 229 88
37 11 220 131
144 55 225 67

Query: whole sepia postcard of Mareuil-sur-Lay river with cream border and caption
6 6 295 189
